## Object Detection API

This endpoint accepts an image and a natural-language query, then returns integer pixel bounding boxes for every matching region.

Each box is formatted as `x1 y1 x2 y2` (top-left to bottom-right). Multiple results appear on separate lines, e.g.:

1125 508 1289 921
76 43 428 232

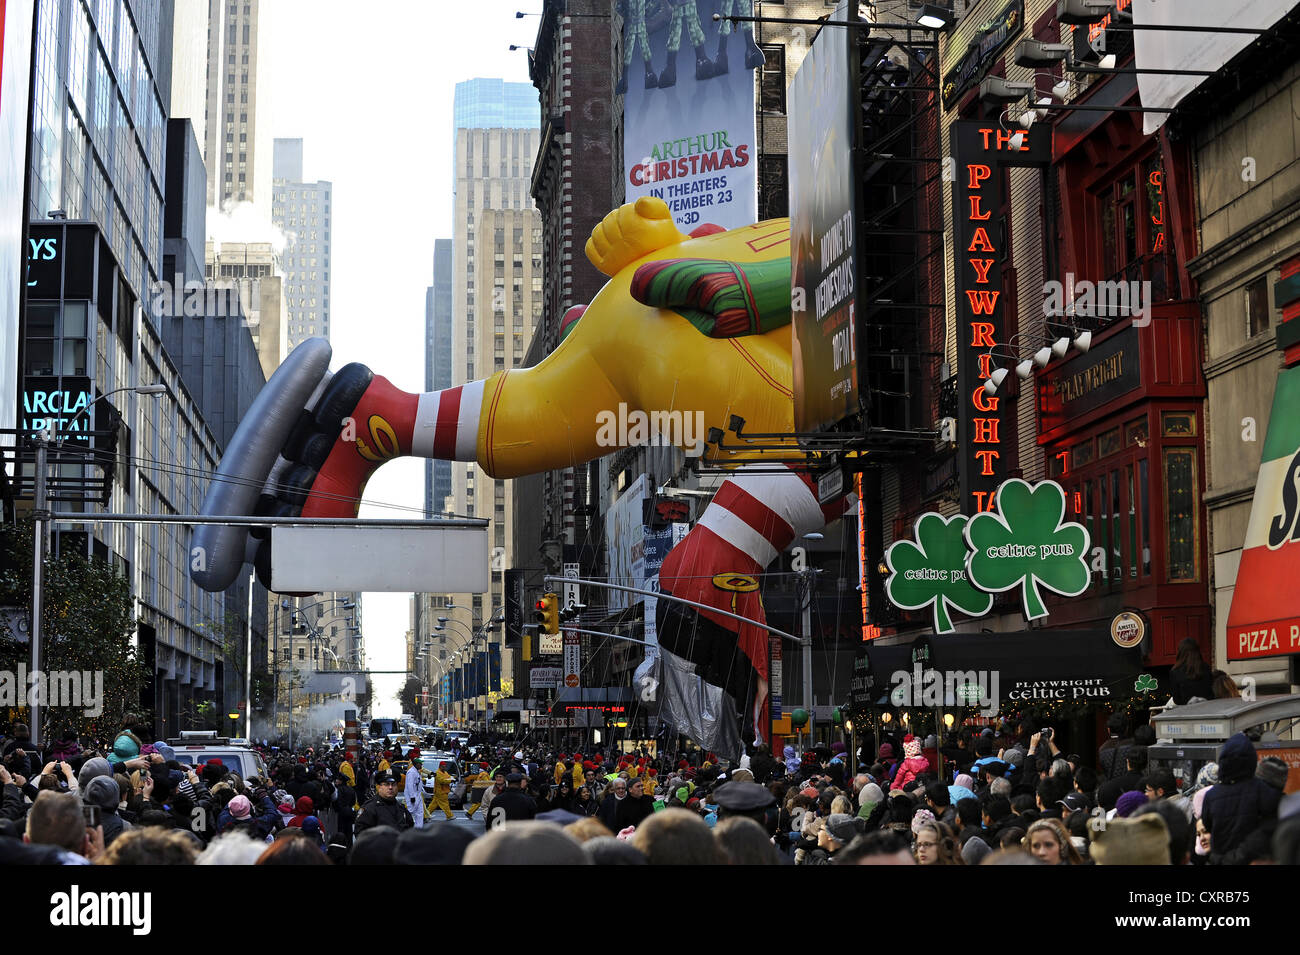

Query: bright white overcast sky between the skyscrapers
259 0 541 716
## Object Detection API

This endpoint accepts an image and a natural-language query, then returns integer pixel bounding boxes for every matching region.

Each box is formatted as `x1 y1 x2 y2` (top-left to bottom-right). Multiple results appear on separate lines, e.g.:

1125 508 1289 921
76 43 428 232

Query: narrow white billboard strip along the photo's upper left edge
0 0 35 429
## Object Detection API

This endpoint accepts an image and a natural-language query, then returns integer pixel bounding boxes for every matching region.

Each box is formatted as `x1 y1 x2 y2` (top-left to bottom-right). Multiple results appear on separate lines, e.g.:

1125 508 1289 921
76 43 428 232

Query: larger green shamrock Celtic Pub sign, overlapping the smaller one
966 478 1089 620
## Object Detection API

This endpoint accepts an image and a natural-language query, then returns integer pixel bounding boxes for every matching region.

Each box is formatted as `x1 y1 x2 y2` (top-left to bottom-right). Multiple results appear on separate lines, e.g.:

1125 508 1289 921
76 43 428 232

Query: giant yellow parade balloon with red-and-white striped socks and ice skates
191 196 854 759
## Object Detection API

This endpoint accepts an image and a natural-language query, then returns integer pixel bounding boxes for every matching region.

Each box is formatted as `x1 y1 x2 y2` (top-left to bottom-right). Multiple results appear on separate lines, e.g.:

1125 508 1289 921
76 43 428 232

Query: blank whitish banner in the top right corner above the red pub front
1121 0 1295 135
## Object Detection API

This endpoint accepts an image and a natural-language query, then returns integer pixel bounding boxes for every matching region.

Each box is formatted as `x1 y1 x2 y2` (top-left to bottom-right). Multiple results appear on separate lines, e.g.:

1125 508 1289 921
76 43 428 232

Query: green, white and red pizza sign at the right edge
1227 366 1300 660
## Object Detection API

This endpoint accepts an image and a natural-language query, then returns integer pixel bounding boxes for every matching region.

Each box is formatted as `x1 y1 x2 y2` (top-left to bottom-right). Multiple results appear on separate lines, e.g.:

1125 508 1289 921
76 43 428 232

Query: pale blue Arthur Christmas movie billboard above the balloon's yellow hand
615 0 763 233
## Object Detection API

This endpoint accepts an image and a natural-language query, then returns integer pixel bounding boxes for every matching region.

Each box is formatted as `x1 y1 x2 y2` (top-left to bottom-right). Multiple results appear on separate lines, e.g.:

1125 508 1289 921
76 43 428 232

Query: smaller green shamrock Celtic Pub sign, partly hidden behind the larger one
885 512 993 633
